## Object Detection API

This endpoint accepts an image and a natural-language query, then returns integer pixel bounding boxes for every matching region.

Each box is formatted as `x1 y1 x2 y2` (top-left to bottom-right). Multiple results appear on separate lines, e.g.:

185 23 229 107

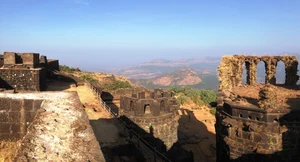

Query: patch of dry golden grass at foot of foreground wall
0 141 19 162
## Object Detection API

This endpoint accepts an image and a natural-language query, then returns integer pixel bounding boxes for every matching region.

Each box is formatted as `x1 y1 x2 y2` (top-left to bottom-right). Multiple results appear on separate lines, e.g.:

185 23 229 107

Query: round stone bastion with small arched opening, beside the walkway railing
120 89 179 150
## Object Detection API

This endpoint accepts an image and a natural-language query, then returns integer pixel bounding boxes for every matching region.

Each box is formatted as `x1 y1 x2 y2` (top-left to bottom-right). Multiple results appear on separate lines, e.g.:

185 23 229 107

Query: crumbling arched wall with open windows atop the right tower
218 55 299 90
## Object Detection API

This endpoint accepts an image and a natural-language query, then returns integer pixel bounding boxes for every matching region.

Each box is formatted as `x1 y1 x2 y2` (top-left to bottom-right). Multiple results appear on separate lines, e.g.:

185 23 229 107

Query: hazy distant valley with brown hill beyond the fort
113 54 299 90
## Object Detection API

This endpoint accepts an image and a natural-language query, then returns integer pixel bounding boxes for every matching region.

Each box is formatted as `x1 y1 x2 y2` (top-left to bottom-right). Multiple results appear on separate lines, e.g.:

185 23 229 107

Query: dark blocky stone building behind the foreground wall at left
0 52 59 91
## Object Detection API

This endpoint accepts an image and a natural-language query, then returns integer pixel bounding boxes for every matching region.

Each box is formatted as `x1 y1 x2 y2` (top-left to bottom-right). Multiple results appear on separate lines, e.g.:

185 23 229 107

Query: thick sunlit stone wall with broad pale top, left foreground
0 92 105 162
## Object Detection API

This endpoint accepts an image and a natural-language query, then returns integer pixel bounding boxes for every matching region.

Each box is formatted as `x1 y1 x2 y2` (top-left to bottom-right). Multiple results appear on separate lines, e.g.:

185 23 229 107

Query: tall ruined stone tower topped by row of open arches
216 55 300 162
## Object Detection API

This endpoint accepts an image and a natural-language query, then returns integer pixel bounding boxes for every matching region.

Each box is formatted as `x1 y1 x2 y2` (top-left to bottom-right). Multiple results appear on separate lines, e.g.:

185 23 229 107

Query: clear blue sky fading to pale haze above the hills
0 0 300 70
